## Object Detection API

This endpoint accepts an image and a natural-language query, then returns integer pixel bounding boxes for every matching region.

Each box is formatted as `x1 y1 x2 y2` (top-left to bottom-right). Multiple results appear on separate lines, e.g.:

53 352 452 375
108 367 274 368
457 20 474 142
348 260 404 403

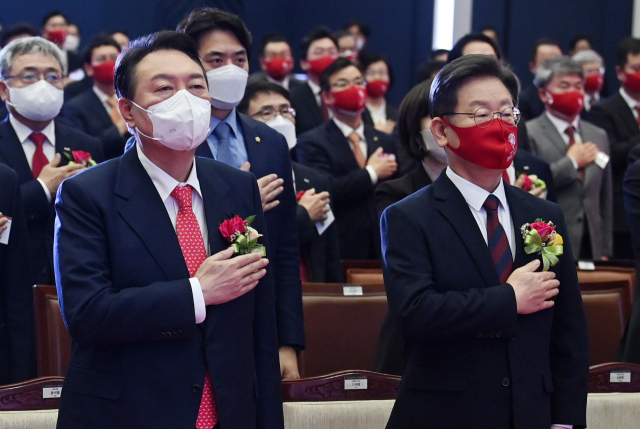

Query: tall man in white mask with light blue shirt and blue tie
178 8 305 378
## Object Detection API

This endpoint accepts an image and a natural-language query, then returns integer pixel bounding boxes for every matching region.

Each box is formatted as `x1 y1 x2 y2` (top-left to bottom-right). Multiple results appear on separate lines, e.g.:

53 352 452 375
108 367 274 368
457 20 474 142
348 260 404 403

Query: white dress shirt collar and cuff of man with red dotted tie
136 143 211 323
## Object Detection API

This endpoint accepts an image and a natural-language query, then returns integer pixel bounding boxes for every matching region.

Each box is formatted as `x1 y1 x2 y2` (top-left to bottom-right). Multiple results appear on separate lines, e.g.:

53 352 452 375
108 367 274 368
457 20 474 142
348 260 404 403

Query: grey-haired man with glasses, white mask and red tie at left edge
0 37 103 284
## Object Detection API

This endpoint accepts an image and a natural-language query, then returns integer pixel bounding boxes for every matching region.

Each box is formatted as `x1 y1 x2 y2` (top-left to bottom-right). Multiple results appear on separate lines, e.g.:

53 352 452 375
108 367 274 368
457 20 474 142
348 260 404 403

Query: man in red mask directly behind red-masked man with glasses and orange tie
291 27 338 136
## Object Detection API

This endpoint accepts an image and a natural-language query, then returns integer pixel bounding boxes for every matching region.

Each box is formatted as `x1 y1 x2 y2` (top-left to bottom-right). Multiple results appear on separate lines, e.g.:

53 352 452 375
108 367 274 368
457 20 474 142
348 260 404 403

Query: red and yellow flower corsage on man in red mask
520 219 564 271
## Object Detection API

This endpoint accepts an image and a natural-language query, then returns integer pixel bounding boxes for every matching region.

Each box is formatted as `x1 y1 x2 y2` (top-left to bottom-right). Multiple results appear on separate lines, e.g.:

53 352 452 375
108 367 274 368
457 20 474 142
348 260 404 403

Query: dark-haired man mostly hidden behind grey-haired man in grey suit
518 38 562 121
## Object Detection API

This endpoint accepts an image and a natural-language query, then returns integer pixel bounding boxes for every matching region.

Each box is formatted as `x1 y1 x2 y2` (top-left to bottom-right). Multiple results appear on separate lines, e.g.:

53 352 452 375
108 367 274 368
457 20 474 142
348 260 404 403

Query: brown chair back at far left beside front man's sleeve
33 285 71 377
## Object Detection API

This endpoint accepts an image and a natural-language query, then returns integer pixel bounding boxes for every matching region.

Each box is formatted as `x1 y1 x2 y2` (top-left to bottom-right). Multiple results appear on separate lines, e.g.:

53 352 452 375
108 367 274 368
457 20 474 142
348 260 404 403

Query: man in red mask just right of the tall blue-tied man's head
248 33 305 91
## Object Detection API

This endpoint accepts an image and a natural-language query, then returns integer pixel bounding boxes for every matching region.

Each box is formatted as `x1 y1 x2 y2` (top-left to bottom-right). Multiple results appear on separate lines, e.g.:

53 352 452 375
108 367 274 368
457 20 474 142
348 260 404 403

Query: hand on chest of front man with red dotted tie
196 247 269 305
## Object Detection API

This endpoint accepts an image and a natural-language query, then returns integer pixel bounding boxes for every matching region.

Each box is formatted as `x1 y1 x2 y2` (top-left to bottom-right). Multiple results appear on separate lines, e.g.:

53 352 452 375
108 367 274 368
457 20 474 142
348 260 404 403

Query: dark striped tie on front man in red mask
482 195 513 283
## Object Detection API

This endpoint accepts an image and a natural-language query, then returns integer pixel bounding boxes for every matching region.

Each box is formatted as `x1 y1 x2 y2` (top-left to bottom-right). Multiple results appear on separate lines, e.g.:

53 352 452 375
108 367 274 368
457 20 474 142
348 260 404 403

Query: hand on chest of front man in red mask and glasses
507 259 560 314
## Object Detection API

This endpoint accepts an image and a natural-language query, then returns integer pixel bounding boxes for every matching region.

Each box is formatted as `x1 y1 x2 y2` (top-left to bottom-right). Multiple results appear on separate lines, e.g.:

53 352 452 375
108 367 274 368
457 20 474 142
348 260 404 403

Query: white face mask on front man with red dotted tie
131 89 211 151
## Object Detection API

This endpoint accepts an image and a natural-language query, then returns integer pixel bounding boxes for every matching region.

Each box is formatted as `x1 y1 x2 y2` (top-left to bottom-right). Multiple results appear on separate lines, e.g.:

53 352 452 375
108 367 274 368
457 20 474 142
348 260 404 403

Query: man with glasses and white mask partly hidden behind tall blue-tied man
238 82 343 283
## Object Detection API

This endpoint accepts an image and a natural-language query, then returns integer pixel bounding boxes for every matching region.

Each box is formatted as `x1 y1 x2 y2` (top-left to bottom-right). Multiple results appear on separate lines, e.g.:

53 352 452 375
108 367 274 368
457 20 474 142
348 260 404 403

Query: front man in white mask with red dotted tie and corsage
55 31 284 429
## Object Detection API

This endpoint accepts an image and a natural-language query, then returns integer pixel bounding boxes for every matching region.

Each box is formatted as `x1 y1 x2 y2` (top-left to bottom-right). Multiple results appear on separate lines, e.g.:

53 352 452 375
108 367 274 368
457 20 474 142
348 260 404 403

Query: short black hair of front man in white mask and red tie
113 30 206 100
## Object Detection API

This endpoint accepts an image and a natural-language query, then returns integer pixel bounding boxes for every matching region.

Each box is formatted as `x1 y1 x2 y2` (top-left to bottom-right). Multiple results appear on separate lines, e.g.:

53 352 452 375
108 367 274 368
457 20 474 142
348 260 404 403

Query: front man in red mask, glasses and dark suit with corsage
381 55 588 429
